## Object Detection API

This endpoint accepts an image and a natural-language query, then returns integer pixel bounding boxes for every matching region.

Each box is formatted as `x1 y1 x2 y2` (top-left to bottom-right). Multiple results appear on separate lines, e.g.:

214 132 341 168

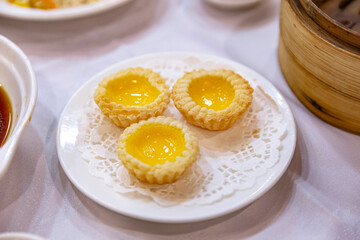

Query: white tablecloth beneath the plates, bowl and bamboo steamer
0 0 360 239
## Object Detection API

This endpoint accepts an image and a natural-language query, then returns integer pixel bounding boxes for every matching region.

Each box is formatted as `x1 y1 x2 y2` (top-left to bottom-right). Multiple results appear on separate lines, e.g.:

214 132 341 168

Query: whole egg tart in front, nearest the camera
117 116 199 184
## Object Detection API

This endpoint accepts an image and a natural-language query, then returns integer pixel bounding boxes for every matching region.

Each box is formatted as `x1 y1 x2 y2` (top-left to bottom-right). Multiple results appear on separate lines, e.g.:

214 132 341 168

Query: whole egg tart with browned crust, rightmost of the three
171 69 254 130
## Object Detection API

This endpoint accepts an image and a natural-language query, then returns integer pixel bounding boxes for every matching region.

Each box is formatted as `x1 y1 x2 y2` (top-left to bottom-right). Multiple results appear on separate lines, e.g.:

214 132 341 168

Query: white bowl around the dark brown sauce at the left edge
0 35 37 177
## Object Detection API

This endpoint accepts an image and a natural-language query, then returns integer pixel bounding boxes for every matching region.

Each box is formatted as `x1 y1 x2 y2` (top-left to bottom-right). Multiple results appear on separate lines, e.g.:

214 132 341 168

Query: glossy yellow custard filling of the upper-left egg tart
105 75 161 106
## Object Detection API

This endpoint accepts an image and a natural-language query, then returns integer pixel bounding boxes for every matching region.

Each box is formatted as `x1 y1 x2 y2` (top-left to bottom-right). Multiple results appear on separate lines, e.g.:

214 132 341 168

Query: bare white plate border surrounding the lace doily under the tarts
57 53 296 223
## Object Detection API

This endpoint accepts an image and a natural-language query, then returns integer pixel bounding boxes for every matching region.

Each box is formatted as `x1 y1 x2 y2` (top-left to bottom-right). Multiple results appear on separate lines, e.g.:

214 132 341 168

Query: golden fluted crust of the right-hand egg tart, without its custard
171 69 254 130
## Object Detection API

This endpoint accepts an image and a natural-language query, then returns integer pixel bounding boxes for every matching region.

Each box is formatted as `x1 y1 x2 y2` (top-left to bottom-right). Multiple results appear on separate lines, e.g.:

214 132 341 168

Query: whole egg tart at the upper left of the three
94 67 170 127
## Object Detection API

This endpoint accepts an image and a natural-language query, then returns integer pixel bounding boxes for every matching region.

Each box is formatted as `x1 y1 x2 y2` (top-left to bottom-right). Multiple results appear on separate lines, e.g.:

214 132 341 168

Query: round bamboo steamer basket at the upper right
278 0 360 134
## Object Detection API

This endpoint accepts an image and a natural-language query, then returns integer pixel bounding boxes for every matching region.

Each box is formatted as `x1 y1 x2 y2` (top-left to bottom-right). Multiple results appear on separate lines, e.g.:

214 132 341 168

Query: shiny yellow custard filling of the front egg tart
126 123 186 166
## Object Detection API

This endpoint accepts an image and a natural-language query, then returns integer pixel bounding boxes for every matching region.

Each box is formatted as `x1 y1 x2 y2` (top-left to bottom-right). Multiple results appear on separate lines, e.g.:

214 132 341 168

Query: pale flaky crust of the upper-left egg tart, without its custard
94 67 170 127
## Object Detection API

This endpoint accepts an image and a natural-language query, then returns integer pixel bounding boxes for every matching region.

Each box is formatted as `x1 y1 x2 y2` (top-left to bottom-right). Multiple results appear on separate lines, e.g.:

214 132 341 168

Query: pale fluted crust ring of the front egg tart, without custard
117 116 199 184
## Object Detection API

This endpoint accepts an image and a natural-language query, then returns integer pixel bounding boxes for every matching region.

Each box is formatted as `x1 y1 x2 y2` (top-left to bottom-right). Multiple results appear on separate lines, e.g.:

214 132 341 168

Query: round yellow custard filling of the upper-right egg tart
189 76 235 111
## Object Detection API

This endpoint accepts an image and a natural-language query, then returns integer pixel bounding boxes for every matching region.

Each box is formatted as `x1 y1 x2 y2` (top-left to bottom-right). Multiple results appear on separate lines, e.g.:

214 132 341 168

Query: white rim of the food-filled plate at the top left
0 0 130 21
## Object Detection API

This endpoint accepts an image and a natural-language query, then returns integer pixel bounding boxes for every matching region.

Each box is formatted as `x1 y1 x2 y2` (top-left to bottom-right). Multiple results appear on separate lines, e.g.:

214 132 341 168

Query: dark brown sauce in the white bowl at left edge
0 84 12 147
